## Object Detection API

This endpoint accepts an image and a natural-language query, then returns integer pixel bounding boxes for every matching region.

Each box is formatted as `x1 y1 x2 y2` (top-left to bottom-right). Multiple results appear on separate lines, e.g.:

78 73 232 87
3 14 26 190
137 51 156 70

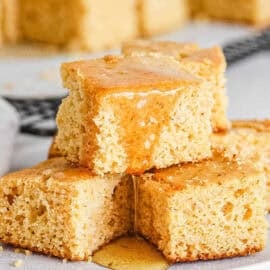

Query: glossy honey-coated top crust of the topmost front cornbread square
61 55 201 95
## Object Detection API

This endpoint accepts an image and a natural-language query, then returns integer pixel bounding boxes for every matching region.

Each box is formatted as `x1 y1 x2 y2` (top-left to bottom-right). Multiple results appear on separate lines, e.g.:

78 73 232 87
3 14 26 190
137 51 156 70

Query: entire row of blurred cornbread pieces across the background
0 0 270 51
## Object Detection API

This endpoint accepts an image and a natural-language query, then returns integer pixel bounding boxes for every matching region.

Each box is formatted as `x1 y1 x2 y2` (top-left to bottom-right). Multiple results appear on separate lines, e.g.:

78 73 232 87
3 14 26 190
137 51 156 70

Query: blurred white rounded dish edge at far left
0 98 19 176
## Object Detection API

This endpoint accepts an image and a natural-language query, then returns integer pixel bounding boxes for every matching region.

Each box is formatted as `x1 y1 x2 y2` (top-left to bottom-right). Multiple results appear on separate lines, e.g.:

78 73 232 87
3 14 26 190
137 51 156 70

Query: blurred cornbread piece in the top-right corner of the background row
190 0 270 26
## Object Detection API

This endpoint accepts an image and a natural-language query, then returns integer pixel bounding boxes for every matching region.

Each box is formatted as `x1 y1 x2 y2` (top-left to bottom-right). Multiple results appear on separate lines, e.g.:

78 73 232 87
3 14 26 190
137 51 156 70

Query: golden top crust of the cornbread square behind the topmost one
122 40 200 58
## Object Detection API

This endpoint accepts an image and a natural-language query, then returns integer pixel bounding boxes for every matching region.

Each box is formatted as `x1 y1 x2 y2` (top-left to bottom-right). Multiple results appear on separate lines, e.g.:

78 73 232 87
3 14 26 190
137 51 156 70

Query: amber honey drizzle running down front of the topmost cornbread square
111 90 180 174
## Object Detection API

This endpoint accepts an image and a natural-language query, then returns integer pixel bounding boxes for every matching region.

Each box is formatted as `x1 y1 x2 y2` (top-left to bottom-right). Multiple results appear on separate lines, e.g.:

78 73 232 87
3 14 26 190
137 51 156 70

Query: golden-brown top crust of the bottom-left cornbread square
2 157 95 182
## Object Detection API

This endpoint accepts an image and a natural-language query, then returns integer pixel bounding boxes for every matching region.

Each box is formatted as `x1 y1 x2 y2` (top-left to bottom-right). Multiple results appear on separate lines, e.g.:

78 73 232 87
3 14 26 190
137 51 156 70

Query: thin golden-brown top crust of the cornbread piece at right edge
232 119 270 132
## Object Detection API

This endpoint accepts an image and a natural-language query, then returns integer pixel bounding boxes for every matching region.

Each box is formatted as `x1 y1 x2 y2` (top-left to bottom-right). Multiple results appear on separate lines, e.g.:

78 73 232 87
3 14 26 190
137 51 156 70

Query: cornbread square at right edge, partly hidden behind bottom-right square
212 120 270 211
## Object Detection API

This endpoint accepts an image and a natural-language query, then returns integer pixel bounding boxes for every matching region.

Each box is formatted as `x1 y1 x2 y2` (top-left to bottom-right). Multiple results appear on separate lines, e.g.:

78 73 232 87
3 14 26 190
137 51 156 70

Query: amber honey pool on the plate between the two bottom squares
93 236 169 270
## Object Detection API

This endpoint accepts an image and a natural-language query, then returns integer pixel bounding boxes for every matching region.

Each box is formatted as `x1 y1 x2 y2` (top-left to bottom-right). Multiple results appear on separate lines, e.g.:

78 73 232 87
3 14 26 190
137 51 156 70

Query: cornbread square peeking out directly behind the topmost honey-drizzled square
122 40 230 131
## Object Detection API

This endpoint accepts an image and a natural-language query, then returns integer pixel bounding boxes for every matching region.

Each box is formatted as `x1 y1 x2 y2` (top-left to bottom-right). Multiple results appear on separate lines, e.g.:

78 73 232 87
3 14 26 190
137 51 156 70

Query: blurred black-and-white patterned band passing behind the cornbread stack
2 29 270 136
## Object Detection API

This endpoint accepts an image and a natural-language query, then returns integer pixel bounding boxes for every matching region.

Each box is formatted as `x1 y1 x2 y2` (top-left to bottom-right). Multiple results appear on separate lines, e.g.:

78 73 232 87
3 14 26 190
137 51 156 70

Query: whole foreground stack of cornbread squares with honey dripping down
0 41 270 262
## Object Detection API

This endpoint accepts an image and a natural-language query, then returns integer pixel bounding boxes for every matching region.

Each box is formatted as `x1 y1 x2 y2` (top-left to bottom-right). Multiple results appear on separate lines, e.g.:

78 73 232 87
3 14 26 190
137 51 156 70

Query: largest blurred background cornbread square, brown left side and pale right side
21 0 138 51
